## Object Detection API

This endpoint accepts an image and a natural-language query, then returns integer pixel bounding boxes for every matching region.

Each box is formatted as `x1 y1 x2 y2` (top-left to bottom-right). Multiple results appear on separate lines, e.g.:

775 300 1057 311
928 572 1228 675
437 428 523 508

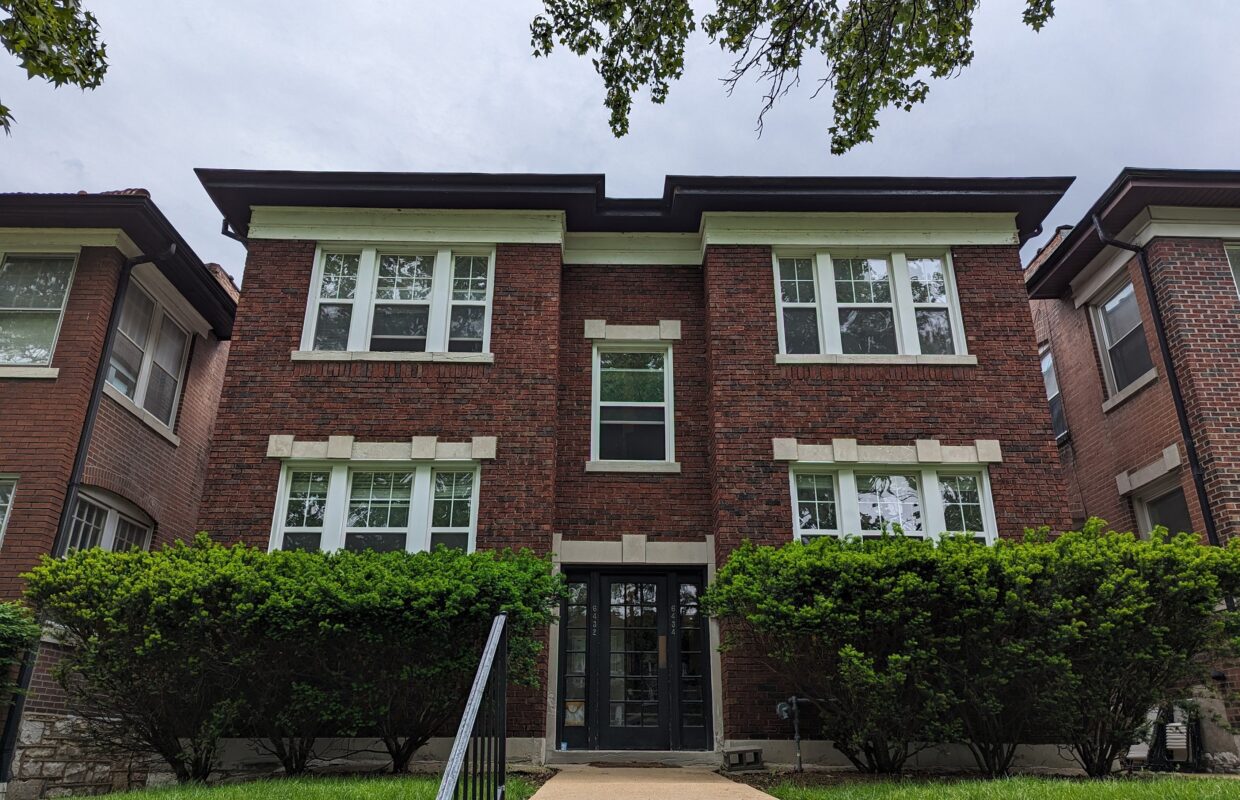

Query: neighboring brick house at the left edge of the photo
0 190 237 796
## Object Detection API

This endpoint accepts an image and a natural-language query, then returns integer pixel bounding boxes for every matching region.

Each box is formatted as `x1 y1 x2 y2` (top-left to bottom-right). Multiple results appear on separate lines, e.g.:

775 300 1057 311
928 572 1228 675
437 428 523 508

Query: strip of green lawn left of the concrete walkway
101 775 534 800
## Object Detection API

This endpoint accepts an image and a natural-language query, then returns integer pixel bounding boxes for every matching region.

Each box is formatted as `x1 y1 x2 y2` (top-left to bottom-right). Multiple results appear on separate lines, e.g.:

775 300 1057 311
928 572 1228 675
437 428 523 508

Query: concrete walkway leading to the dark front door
533 765 773 800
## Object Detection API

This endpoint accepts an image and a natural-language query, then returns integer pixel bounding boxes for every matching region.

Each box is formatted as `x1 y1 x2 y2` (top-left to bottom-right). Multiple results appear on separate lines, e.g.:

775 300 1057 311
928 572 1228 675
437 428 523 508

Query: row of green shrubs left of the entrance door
13 537 563 781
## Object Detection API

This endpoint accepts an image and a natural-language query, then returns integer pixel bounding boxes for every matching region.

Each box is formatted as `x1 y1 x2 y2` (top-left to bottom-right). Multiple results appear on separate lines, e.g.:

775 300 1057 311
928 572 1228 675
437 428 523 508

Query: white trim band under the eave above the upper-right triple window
702 211 1019 248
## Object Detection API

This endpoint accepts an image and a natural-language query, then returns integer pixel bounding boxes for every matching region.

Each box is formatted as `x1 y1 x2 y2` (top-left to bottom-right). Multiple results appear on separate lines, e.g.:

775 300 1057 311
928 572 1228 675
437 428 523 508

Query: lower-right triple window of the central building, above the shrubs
791 465 997 542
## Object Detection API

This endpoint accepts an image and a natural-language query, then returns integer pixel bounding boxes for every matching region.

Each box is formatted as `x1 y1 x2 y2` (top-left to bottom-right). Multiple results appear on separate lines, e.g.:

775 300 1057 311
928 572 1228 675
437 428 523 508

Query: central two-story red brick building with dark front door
200 170 1070 760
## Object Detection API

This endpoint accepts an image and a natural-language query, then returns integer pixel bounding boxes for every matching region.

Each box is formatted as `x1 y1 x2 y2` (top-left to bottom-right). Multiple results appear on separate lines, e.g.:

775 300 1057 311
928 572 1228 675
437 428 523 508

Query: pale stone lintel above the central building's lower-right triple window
771 438 1003 465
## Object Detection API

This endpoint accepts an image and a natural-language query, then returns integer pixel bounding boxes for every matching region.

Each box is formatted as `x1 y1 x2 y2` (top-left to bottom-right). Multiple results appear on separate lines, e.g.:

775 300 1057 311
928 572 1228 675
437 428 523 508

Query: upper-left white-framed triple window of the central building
301 247 495 353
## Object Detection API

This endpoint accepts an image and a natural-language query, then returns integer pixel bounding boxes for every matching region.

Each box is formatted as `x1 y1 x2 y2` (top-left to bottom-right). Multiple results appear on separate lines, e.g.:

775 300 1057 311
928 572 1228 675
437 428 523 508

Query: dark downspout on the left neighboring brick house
0 244 176 783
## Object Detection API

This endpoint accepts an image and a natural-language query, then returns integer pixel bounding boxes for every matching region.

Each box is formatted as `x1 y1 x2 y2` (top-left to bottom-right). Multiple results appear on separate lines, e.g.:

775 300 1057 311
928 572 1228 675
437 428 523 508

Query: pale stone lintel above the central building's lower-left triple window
267 434 498 461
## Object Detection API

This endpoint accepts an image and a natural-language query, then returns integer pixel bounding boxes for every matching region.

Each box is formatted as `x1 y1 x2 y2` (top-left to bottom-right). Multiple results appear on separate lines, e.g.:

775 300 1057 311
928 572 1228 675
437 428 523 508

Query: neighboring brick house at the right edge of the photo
1025 167 1240 722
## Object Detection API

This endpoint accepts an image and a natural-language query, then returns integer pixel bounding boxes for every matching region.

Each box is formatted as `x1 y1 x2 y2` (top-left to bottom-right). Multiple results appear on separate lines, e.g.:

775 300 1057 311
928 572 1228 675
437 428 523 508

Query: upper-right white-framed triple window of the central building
775 251 965 356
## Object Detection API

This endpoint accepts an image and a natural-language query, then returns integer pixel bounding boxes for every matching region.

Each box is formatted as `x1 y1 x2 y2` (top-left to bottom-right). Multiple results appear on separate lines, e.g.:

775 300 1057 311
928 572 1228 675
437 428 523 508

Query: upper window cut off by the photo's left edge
0 253 77 366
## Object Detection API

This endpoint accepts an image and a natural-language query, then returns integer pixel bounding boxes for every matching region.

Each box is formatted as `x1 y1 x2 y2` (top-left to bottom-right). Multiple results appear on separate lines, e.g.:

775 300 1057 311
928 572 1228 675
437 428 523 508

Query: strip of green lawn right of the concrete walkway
766 776 1240 800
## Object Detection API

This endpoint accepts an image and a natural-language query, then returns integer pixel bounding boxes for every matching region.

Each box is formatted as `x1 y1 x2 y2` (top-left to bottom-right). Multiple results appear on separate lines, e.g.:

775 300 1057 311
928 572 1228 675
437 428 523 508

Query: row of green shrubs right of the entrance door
704 520 1240 776
